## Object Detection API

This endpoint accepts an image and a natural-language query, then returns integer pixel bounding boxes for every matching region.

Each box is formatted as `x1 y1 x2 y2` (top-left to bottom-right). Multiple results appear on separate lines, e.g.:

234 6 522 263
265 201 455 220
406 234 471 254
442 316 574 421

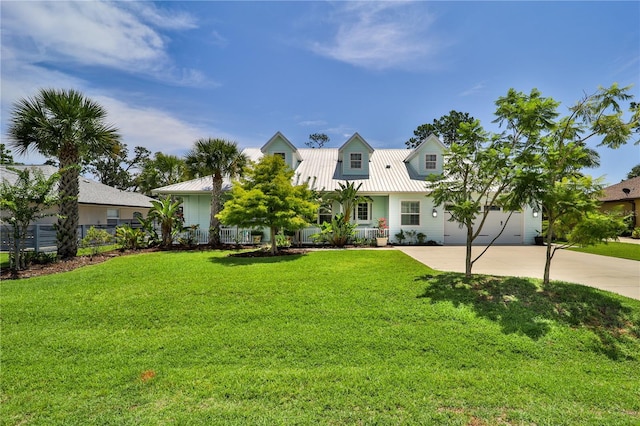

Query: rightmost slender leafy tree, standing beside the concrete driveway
504 84 640 284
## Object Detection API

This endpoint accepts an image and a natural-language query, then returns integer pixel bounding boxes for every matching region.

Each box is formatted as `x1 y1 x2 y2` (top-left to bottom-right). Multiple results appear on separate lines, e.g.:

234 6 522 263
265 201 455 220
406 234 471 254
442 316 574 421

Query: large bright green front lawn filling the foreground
0 250 640 425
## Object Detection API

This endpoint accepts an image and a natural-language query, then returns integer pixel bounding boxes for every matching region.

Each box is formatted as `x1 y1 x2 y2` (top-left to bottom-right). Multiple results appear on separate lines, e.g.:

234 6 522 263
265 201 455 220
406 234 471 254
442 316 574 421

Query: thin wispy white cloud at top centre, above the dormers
310 2 443 69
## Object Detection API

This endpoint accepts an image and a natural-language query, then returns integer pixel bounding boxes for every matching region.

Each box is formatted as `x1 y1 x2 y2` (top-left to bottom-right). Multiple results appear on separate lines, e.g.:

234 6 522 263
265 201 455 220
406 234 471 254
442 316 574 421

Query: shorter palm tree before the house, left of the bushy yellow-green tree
185 138 247 246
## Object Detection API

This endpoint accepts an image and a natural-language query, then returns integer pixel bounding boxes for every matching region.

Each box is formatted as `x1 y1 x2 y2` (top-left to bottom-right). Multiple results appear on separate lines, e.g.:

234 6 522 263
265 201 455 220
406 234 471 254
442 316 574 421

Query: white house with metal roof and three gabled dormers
152 132 541 244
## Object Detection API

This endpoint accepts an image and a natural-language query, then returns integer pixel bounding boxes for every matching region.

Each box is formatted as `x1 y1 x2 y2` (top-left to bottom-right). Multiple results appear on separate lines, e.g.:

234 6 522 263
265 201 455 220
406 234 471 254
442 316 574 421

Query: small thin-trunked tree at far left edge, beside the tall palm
0 168 60 277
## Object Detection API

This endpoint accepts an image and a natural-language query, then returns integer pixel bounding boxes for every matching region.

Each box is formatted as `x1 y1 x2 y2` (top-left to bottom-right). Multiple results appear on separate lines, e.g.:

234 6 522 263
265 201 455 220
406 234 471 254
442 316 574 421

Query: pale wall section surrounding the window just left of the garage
389 194 444 244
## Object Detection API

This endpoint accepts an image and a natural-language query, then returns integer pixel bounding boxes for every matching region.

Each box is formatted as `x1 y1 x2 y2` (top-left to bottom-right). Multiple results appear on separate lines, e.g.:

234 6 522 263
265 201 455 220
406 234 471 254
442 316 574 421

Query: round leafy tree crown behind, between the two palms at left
135 152 188 195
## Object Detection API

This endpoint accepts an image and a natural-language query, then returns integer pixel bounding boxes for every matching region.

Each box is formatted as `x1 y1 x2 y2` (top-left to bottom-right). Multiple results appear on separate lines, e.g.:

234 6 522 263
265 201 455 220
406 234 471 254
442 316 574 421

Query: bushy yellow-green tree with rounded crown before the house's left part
218 155 318 254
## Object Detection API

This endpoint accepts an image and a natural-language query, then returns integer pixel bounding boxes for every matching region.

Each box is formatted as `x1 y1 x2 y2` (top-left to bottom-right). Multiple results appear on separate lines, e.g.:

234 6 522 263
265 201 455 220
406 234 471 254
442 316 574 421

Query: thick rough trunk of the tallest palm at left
57 155 80 259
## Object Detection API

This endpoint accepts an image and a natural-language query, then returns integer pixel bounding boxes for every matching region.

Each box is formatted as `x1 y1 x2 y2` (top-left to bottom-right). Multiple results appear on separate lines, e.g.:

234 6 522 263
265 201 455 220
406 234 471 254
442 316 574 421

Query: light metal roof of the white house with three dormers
153 148 426 194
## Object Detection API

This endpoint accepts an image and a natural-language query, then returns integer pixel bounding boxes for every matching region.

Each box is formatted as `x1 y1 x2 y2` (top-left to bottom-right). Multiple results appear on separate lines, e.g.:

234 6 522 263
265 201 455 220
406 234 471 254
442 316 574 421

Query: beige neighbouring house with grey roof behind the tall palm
0 165 152 226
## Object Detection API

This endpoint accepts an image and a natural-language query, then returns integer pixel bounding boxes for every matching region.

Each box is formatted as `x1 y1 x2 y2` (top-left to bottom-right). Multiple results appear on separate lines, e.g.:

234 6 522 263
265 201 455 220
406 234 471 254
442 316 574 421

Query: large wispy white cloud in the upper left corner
2 1 204 85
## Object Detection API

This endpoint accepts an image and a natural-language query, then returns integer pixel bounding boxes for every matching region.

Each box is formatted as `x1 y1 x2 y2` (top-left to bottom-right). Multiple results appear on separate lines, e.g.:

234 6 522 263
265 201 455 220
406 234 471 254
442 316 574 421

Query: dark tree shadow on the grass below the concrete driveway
416 273 640 360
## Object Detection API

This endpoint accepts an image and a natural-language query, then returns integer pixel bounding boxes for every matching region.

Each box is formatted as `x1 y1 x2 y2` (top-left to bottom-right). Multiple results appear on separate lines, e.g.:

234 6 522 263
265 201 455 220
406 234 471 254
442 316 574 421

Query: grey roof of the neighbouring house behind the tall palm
0 165 153 208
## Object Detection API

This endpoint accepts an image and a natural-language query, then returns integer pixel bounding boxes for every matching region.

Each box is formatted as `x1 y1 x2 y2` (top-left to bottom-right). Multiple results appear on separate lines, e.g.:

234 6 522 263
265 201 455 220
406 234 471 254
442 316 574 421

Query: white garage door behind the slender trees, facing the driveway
444 207 522 245
